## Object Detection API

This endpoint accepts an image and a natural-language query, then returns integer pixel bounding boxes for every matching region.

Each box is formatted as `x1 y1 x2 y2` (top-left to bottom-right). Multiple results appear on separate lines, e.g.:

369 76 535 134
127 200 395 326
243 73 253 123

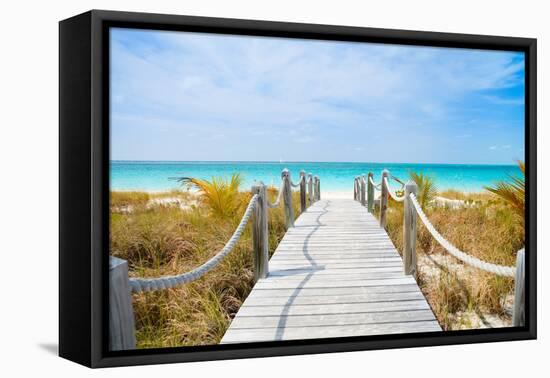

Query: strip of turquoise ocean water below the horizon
110 161 520 192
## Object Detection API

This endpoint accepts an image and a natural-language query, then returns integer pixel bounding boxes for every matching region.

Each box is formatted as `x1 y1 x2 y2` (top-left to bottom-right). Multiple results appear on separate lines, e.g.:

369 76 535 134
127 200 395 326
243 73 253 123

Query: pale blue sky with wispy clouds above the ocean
111 29 525 164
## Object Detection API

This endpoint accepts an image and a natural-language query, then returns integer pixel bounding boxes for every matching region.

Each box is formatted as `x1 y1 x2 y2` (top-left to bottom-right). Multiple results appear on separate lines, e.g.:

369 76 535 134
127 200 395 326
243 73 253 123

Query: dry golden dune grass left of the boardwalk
110 188 299 348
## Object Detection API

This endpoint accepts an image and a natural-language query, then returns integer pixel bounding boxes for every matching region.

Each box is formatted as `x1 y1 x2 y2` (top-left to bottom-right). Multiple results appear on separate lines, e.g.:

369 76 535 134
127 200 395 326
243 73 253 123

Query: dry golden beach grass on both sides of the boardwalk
110 171 525 348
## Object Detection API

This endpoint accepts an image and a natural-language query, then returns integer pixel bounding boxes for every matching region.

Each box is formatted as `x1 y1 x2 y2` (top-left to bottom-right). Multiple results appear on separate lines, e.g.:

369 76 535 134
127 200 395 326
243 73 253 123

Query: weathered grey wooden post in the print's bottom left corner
109 256 136 350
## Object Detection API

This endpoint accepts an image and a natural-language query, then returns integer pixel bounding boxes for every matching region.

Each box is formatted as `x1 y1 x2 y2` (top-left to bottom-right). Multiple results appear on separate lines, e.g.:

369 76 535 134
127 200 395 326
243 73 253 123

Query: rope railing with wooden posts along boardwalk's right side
354 170 525 326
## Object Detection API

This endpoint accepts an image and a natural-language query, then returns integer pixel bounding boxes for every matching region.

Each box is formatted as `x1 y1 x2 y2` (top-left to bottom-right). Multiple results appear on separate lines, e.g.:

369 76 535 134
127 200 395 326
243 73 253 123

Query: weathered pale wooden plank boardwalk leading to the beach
222 199 441 343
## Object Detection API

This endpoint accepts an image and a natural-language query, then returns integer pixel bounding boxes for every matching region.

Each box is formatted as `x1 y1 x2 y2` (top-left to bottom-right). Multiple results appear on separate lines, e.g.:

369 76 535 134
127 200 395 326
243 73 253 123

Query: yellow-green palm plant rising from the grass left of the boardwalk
177 173 243 218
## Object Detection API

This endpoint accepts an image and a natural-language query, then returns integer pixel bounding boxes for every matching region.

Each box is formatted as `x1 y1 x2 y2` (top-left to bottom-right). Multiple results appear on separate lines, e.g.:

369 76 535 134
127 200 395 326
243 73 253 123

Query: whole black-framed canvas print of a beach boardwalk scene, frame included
59 11 536 367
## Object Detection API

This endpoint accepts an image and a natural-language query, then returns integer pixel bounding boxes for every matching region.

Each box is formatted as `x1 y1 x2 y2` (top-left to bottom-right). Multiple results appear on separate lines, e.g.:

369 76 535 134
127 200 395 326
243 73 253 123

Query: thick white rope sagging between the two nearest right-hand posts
409 193 516 277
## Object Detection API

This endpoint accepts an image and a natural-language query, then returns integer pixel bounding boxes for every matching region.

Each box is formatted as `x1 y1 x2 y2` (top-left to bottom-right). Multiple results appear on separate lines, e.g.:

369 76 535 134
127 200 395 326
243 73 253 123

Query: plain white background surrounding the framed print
0 0 550 378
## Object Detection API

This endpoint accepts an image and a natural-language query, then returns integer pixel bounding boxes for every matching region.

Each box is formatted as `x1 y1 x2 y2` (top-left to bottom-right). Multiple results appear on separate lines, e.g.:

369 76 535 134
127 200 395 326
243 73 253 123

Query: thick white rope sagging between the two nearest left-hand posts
130 194 259 293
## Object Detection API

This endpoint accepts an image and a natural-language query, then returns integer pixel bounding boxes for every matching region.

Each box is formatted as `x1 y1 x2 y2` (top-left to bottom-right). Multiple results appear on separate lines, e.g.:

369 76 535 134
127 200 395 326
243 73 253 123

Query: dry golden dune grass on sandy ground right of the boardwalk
387 173 525 330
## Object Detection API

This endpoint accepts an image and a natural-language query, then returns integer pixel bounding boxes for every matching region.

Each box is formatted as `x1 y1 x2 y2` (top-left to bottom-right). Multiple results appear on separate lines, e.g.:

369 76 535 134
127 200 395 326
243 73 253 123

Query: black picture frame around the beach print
59 10 537 367
